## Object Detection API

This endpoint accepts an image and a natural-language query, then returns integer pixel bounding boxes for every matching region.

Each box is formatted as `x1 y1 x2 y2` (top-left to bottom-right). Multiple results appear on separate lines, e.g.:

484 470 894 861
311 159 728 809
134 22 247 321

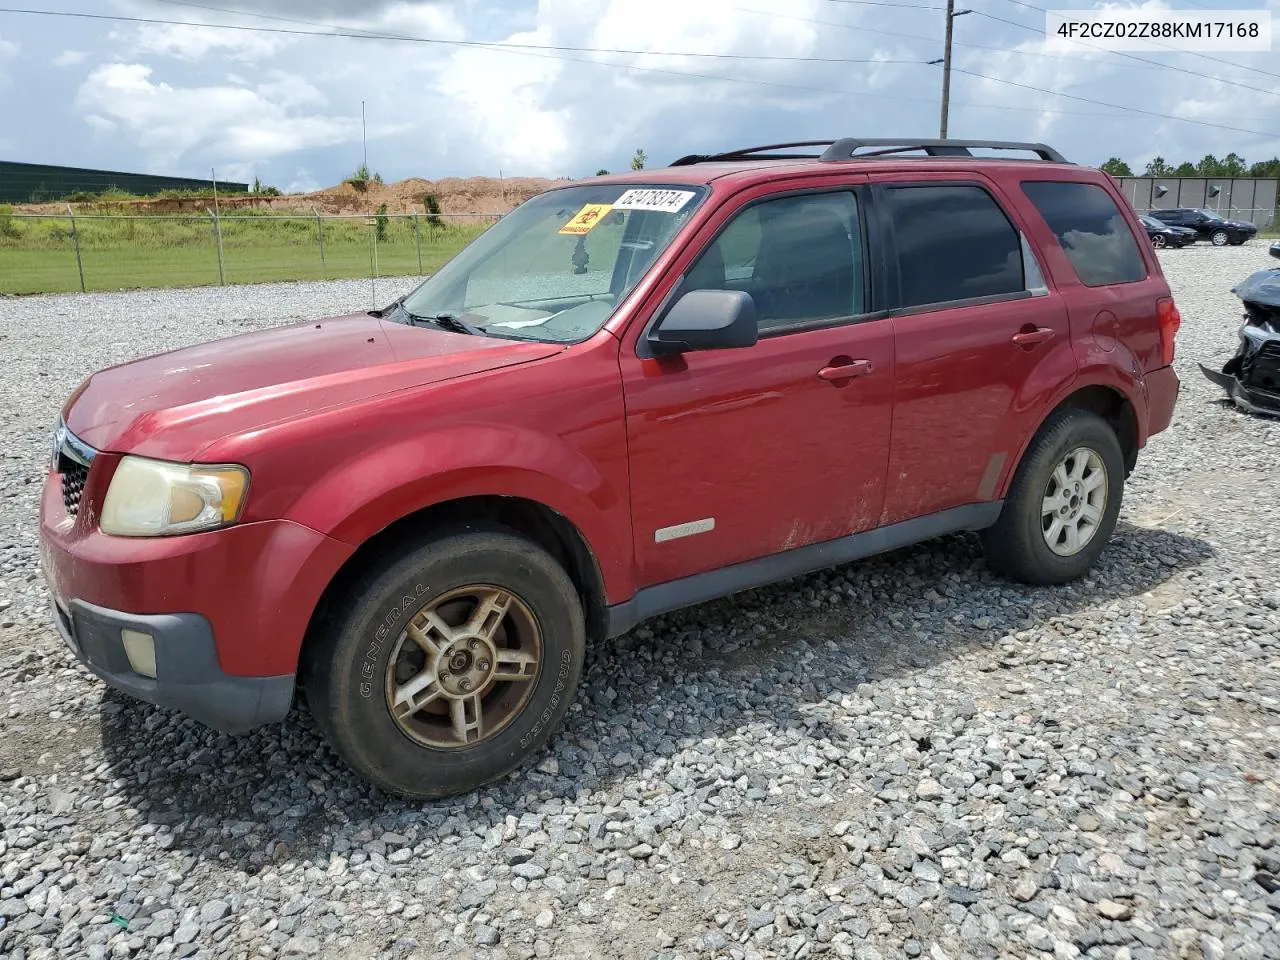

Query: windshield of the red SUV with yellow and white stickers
402 183 707 343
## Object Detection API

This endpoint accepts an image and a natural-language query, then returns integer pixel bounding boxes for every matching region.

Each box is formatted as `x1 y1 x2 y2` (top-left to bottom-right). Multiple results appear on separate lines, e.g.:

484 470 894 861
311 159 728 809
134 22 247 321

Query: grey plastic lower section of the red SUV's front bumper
54 600 293 733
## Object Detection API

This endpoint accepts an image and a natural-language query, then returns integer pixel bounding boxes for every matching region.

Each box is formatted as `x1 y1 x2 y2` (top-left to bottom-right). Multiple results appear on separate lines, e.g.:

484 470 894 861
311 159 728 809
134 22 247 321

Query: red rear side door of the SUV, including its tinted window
873 174 1075 524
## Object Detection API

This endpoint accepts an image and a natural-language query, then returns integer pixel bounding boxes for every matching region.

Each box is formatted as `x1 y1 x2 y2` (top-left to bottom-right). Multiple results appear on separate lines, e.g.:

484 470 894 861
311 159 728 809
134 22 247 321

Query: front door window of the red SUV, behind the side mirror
685 192 867 333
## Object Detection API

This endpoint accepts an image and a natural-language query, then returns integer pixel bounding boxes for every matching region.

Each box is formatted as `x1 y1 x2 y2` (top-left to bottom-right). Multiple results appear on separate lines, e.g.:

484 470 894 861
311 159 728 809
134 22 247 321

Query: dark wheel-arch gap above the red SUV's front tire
298 494 608 675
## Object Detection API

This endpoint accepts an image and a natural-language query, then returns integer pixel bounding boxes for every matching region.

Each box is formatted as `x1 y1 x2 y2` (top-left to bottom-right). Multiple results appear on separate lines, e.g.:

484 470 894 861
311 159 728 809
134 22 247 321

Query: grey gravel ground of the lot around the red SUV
0 249 1280 960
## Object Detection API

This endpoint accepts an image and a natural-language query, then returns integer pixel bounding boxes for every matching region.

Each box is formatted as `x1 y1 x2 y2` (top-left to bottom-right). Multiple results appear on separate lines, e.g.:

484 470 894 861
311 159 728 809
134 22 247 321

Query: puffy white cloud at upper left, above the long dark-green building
77 63 360 168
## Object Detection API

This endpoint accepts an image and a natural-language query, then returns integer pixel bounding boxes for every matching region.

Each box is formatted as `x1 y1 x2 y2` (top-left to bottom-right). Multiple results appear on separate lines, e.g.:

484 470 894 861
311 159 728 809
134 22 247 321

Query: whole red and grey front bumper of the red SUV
40 440 353 732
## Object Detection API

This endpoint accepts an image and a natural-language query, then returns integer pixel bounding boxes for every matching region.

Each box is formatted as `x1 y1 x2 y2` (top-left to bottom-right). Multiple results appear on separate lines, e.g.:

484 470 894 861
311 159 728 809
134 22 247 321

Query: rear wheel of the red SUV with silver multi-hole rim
982 407 1125 585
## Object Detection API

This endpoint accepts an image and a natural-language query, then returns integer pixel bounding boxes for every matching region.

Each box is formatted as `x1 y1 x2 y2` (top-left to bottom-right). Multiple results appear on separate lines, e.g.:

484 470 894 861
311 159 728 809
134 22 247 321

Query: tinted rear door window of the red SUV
886 184 1024 307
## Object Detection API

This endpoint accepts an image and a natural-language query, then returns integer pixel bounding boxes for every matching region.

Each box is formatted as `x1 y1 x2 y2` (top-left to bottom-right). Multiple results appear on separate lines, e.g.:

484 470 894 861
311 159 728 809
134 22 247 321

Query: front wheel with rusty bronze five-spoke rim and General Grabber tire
303 530 586 797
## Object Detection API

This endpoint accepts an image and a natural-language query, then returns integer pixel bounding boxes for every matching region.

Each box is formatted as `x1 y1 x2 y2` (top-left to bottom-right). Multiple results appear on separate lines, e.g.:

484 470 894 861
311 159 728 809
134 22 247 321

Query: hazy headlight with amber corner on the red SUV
99 457 248 536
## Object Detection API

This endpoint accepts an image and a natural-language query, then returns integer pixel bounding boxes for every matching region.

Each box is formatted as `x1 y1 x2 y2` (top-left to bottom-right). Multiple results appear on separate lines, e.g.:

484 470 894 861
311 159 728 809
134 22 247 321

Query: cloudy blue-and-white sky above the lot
0 0 1280 189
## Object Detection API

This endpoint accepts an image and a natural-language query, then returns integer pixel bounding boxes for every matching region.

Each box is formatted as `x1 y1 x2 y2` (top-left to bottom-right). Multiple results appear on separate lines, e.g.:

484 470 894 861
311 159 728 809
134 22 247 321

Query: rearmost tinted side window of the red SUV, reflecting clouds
1023 180 1147 287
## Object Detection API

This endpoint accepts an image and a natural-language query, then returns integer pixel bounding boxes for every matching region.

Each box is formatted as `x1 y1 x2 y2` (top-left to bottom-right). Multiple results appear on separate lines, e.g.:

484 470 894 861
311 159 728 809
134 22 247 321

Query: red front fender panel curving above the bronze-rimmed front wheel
288 424 632 603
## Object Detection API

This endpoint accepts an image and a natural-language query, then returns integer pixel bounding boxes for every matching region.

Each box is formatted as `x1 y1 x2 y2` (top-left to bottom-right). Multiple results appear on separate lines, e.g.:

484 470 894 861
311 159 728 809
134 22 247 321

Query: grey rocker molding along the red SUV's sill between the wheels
605 500 1005 637
